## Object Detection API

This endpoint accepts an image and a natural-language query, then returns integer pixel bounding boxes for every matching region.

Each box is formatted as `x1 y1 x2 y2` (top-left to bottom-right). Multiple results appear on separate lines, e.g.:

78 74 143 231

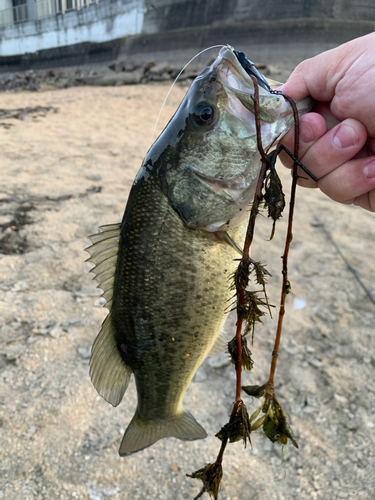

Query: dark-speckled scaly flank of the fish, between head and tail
112 174 242 392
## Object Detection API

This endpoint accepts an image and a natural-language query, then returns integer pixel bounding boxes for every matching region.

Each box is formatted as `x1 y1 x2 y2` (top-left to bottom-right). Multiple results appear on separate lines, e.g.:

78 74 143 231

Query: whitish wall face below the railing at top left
0 0 144 57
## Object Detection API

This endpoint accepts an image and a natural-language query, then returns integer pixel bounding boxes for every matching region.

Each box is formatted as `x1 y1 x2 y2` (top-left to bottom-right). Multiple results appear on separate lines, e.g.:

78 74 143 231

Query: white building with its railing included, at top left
0 0 144 57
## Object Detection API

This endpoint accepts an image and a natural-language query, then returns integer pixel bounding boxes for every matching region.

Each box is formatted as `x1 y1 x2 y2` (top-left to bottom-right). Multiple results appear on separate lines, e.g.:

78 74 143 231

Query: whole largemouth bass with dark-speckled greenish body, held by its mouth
87 46 310 456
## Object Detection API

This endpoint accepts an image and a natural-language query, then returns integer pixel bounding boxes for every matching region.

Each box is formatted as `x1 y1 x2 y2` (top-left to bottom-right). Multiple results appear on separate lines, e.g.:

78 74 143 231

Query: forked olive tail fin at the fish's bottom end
119 410 207 457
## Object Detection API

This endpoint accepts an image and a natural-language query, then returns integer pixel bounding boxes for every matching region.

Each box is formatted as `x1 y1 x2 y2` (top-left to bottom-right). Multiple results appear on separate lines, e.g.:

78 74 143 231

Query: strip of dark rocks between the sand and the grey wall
0 50 290 95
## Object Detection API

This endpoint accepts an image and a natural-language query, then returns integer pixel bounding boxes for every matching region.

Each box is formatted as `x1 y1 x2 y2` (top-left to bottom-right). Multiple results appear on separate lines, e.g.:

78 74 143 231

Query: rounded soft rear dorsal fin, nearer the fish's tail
90 313 131 406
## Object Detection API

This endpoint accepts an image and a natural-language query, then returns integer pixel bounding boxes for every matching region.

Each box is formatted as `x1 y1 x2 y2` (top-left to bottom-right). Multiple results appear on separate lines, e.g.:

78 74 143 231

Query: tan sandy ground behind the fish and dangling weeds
0 79 375 500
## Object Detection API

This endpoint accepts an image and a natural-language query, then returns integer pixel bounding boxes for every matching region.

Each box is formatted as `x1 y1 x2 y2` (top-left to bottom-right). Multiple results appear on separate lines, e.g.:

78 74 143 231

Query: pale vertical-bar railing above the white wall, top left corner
0 0 99 27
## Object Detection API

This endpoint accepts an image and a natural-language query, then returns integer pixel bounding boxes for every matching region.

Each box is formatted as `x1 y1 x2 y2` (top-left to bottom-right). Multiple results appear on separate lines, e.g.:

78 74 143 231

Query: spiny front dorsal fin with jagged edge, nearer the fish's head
86 224 121 310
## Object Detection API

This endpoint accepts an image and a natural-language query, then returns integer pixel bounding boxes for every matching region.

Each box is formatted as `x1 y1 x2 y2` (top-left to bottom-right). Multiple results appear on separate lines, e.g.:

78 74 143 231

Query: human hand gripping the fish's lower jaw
280 33 375 212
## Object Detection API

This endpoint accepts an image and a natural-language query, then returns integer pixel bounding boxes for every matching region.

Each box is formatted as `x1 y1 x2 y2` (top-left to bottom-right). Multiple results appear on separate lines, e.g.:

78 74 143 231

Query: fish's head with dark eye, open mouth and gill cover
140 46 311 232
